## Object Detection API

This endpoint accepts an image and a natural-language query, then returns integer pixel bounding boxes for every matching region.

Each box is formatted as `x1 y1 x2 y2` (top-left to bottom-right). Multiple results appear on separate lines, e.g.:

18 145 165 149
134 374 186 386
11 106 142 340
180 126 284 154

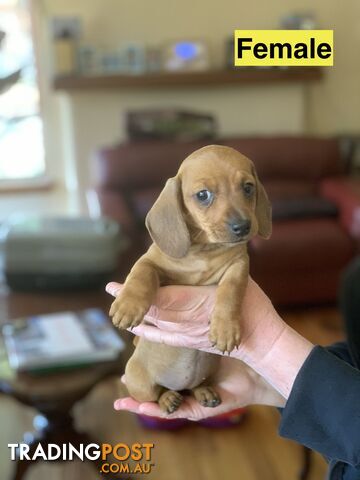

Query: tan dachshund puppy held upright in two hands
110 145 271 413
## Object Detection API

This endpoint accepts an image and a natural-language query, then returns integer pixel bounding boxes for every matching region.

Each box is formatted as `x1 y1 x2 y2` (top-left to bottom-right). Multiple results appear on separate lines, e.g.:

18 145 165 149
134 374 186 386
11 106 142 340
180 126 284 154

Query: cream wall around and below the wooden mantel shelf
34 0 360 208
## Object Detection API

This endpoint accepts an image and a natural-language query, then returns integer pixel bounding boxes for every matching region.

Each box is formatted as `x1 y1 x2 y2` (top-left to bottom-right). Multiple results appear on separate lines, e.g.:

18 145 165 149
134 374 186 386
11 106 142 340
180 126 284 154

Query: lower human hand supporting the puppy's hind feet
114 357 285 421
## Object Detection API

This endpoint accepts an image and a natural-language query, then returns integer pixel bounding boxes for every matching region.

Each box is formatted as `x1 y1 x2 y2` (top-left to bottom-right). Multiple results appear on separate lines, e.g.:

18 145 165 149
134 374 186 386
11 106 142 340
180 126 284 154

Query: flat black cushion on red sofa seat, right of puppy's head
272 197 338 220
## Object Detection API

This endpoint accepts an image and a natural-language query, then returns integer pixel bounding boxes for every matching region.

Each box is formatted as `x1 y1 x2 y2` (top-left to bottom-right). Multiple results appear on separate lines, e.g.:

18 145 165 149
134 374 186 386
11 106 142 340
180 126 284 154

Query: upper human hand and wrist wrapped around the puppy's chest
106 278 313 398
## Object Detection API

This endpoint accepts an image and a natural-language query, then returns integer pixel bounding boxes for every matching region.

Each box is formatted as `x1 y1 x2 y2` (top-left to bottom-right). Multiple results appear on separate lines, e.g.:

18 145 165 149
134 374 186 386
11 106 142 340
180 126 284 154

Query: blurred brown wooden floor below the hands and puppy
0 308 343 480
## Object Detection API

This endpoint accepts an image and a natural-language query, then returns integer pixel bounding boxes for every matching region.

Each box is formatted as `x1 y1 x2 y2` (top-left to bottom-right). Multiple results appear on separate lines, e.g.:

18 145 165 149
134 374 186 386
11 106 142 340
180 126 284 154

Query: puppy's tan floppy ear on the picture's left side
145 177 190 258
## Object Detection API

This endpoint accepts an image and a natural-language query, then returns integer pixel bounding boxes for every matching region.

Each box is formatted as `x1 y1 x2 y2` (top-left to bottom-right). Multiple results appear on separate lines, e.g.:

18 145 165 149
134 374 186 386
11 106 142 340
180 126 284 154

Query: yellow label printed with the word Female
234 30 334 67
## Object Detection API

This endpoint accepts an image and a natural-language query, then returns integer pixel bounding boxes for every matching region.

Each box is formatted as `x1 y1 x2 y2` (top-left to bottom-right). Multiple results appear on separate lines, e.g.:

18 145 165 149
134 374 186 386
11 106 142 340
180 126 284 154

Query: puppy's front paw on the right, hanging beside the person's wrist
209 316 241 353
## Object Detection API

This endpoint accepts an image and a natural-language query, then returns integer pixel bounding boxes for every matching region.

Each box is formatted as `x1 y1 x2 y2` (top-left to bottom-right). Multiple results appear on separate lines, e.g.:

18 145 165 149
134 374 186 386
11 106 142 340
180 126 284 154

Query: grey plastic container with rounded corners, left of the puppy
0 216 126 290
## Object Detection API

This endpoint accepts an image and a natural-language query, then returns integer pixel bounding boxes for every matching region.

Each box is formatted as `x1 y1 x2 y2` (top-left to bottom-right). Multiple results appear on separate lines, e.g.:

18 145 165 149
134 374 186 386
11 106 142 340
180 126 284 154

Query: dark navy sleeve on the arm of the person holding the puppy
279 344 360 466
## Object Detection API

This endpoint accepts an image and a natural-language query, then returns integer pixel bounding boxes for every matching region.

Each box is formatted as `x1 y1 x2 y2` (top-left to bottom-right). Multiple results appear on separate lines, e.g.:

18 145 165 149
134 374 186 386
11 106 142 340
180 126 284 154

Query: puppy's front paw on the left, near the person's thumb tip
109 295 149 329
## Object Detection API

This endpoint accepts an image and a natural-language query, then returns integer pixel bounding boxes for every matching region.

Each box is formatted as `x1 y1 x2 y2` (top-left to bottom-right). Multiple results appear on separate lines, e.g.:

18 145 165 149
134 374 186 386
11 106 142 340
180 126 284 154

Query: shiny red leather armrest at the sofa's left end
87 188 136 233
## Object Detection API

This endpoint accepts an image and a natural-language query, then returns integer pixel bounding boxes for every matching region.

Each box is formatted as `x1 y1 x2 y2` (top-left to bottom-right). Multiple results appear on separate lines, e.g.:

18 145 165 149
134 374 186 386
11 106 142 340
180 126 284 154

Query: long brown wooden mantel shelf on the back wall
54 67 322 91
